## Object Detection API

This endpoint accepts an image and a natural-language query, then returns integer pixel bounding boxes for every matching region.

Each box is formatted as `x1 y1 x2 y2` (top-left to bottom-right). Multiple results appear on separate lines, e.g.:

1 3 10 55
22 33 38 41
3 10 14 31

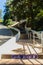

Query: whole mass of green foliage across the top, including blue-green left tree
4 0 43 30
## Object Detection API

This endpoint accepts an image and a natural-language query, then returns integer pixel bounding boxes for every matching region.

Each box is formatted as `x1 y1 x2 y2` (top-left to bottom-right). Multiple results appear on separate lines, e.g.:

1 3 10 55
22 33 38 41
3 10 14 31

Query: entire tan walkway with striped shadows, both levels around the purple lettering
0 40 43 65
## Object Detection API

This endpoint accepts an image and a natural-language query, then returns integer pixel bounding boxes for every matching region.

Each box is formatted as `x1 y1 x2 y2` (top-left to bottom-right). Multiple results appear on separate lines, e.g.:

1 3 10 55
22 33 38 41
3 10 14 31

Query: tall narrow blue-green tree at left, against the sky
3 0 12 25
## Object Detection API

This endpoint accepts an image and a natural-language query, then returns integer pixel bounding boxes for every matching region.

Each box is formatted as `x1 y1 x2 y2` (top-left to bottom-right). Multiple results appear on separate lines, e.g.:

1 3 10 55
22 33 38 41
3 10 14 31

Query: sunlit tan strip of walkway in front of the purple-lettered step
0 59 43 65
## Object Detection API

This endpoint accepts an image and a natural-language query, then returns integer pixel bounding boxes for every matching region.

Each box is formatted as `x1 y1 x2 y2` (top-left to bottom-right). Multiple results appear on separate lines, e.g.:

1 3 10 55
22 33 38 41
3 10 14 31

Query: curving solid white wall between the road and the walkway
0 28 20 59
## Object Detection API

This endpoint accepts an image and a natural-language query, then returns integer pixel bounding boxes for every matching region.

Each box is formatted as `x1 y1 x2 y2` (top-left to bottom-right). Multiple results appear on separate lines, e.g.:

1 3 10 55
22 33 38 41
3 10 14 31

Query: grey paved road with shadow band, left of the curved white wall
0 24 12 45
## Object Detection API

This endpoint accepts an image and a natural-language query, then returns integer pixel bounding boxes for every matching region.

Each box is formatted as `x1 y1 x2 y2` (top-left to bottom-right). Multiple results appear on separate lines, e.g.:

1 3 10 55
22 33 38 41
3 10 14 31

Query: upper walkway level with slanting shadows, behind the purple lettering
2 40 42 59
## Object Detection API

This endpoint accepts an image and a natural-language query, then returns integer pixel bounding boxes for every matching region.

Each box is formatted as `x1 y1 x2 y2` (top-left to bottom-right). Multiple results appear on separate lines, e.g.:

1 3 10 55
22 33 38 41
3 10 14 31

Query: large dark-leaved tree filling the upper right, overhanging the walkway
10 0 43 29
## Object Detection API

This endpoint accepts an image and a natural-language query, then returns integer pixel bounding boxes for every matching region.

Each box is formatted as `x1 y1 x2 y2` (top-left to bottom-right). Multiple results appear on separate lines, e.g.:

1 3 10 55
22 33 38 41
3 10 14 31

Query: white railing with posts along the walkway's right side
25 26 43 53
